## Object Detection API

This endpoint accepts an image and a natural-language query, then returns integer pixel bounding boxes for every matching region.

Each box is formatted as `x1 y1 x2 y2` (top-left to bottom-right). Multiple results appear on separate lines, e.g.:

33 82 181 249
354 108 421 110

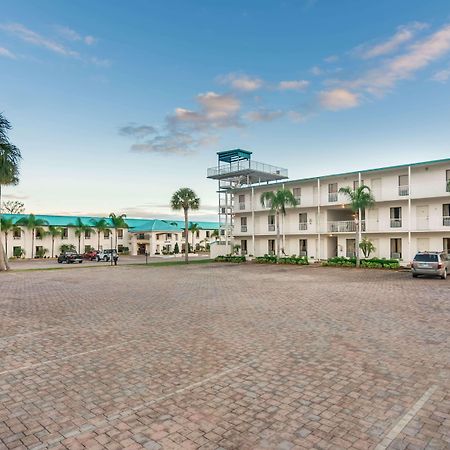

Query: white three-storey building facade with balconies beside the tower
233 159 450 264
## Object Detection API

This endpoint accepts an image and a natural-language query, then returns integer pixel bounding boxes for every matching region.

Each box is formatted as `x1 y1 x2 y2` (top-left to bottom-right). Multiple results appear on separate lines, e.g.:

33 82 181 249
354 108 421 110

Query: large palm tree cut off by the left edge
0 113 22 270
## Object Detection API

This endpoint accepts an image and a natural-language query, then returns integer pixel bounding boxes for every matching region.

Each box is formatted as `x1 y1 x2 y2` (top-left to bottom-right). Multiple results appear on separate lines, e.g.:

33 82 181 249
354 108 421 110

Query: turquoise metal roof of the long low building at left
2 214 219 232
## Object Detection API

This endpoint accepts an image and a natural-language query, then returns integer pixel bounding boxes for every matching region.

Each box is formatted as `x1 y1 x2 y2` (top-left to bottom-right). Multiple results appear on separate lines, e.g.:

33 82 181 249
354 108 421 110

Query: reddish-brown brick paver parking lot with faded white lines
0 264 450 450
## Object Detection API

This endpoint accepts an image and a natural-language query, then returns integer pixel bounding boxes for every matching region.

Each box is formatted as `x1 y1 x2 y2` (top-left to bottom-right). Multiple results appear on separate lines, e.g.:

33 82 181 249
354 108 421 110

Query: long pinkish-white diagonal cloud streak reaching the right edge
347 25 450 95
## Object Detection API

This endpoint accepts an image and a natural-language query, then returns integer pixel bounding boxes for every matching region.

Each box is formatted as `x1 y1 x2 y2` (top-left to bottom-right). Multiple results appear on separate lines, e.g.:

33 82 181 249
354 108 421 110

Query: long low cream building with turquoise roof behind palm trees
1 214 218 258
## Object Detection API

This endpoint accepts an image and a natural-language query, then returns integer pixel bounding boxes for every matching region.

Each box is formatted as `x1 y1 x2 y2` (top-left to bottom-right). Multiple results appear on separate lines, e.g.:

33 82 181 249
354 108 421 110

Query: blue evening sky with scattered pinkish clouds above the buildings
0 0 450 220
